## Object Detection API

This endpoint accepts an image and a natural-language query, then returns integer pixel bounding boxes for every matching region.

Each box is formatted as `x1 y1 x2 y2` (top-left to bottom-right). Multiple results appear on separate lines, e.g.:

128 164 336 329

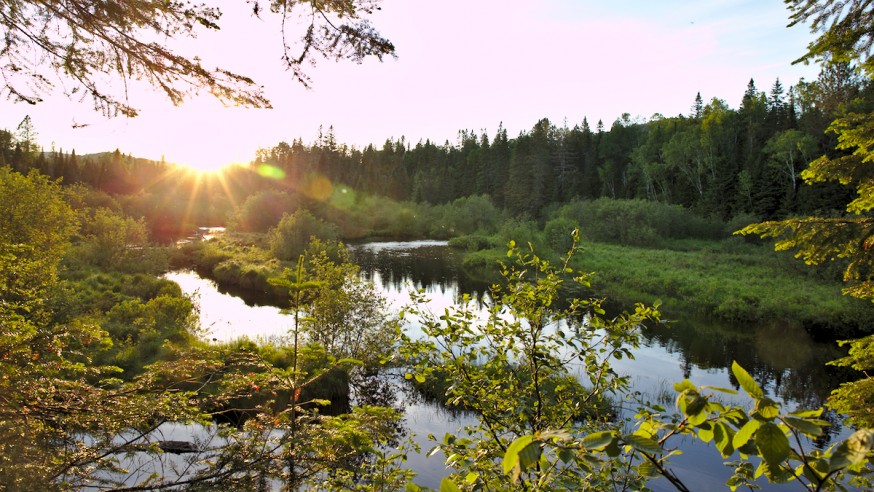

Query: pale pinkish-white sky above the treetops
0 0 819 168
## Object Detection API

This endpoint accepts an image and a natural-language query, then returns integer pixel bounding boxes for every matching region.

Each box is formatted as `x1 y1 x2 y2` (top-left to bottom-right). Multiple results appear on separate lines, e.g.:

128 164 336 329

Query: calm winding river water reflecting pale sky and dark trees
167 241 845 490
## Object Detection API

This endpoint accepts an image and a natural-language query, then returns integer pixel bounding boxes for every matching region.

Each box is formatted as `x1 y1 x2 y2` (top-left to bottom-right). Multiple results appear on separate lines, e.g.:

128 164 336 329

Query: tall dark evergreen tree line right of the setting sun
252 63 872 220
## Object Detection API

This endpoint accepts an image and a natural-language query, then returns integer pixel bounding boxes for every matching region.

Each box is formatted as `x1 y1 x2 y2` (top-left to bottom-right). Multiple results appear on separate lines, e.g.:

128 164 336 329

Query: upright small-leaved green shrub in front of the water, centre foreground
401 236 658 490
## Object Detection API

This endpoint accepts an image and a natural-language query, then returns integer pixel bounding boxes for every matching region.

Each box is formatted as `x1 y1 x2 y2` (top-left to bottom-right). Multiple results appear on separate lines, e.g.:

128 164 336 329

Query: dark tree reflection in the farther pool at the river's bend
353 246 489 297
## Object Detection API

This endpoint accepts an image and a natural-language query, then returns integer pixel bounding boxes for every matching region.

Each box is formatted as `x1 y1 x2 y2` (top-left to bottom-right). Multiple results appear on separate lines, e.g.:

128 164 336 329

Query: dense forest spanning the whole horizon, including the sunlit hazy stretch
0 64 874 236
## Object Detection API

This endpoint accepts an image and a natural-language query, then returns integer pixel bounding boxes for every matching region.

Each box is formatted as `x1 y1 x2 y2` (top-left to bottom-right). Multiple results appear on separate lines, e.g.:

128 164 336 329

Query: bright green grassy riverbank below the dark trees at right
463 238 874 339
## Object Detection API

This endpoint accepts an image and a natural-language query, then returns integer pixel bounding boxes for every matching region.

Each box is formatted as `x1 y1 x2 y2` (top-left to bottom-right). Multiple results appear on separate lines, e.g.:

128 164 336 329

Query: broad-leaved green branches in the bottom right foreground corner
504 363 874 491
